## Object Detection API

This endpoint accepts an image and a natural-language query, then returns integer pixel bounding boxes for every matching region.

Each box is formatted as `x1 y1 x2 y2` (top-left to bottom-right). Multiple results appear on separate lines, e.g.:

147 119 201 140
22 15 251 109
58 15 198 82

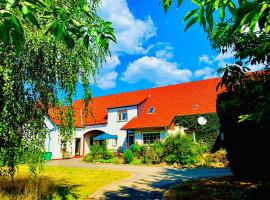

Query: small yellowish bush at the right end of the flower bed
196 149 229 168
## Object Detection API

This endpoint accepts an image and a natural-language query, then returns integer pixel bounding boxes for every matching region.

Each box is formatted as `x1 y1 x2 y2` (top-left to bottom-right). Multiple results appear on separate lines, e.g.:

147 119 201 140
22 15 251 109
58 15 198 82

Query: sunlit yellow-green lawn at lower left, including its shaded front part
0 166 130 200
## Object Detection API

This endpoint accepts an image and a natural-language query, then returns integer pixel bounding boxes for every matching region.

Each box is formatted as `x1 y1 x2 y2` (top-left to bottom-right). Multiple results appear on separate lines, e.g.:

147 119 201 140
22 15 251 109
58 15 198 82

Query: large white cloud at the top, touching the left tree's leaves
100 0 156 54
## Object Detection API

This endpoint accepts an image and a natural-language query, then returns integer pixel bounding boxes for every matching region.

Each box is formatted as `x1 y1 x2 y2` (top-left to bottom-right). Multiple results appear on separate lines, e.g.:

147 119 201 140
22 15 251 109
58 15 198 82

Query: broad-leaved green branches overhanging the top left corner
0 0 115 53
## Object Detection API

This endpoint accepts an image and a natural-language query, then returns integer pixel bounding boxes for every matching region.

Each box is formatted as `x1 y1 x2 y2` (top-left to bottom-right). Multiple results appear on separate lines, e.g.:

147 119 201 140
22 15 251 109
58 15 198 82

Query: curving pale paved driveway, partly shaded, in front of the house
46 159 231 200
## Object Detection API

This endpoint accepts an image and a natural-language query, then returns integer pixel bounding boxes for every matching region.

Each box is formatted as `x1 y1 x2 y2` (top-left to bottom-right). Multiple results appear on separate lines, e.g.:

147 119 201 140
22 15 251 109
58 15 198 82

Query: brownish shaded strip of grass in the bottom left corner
0 177 79 200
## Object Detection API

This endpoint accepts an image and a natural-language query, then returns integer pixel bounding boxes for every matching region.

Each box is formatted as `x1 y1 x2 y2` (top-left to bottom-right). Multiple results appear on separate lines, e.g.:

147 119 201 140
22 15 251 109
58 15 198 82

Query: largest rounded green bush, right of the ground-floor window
163 133 207 166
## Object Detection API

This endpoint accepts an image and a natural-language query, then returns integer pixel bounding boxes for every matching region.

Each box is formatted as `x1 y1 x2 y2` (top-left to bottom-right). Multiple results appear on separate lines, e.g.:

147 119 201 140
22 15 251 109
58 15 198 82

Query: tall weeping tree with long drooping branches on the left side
0 0 115 178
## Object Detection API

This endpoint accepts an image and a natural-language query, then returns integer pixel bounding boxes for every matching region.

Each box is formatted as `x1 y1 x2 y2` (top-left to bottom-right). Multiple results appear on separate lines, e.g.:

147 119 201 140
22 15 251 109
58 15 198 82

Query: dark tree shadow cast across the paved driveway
104 168 231 200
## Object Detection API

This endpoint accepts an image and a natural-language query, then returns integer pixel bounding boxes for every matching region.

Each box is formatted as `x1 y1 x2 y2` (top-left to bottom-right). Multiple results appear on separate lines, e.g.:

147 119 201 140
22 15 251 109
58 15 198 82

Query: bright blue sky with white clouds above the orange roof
75 0 240 99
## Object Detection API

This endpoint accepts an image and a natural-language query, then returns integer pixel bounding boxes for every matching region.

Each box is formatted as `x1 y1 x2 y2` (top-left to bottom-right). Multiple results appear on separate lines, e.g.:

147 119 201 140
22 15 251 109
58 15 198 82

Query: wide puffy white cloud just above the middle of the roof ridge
121 56 192 85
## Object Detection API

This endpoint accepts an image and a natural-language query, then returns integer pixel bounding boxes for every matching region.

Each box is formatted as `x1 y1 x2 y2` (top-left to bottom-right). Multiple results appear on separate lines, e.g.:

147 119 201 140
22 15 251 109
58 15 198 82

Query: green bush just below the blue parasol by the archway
84 144 113 162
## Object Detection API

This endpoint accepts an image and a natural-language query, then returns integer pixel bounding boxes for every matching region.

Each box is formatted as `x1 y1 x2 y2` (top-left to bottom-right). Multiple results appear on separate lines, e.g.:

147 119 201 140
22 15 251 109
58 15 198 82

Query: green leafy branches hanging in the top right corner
162 0 270 67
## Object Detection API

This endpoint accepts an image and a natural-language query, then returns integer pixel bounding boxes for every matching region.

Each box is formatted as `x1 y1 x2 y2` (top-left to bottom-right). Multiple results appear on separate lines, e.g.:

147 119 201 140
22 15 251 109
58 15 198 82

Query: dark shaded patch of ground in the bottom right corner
164 177 270 200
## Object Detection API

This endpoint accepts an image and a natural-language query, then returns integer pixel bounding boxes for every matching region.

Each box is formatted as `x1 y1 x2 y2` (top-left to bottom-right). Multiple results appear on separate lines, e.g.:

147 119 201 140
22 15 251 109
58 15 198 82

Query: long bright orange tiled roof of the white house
49 78 220 129
